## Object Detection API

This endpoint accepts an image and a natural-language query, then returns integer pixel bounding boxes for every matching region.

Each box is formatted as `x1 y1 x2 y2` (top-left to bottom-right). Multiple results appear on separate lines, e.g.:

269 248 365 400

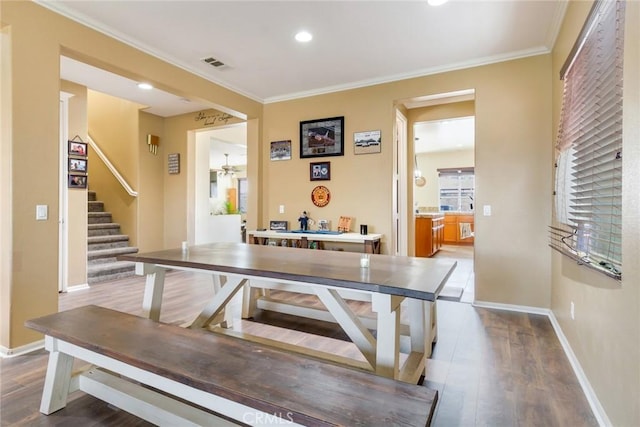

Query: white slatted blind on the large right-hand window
551 1 624 278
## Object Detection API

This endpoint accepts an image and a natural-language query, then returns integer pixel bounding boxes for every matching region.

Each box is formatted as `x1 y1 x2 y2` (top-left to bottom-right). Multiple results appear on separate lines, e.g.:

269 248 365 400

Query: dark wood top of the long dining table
118 243 456 301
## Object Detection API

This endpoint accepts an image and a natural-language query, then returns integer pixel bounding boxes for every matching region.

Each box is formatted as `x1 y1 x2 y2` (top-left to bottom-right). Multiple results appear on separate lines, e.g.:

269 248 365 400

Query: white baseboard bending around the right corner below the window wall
473 301 612 427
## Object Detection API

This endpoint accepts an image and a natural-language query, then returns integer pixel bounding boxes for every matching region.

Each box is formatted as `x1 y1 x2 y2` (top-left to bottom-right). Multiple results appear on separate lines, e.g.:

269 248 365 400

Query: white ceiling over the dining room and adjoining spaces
50 0 567 155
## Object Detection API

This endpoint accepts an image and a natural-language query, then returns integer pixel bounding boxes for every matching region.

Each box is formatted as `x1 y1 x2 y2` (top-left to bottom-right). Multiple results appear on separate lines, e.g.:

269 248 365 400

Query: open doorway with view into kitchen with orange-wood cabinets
413 116 475 303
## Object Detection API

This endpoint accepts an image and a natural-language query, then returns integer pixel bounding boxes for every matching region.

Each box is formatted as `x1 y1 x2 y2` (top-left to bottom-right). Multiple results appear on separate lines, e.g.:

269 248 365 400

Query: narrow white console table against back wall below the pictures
247 230 382 254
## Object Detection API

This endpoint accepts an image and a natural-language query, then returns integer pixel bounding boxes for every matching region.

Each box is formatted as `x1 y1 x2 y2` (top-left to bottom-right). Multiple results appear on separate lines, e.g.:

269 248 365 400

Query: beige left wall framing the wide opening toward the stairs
0 1 262 348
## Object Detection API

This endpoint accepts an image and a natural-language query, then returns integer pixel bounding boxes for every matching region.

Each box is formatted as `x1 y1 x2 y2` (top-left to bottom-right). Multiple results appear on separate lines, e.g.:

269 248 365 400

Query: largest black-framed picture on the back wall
300 117 344 159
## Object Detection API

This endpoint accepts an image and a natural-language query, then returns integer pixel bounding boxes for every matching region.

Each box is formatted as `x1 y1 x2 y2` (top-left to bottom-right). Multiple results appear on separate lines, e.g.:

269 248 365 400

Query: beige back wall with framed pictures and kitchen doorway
262 55 552 307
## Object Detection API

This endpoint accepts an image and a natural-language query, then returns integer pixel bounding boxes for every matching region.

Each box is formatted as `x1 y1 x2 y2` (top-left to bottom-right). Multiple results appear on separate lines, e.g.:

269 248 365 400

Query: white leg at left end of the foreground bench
40 337 73 415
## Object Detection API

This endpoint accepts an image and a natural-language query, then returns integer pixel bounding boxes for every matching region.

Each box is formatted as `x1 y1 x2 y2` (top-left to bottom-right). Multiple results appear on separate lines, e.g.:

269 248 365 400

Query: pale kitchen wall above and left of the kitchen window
413 149 475 209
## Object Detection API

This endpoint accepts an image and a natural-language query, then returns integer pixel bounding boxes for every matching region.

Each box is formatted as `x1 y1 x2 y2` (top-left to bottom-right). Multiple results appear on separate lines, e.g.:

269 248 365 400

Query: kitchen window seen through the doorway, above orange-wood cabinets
438 168 475 212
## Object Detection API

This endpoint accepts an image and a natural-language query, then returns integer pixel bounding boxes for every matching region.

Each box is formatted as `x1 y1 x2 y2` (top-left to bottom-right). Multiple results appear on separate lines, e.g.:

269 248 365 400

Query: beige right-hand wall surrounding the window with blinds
551 2 640 426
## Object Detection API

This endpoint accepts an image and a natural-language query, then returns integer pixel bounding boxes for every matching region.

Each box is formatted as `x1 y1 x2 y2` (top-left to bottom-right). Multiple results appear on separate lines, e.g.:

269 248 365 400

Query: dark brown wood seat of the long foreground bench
26 305 437 426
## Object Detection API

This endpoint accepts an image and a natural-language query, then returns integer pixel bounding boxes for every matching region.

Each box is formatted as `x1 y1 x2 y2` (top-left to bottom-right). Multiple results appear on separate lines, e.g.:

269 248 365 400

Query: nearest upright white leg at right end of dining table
371 293 402 379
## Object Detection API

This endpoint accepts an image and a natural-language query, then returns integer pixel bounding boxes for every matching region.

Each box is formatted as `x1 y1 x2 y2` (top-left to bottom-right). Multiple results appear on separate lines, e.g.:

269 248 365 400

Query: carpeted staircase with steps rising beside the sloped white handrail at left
87 191 138 284
